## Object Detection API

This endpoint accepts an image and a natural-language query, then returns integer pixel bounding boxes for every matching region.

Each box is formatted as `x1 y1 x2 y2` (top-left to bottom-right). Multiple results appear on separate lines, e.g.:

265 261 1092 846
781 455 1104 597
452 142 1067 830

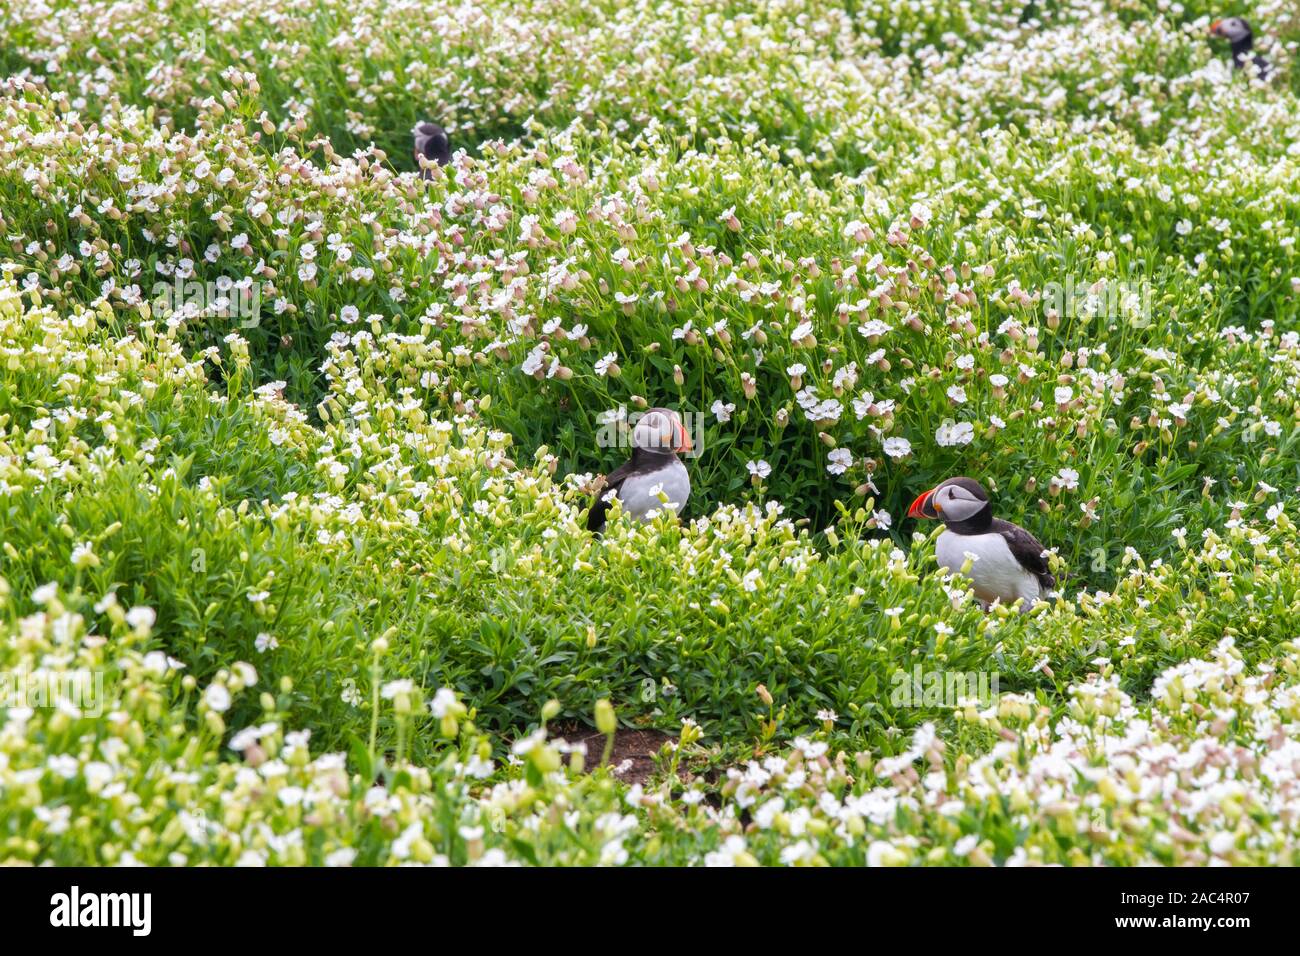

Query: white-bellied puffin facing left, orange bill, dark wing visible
907 477 1056 614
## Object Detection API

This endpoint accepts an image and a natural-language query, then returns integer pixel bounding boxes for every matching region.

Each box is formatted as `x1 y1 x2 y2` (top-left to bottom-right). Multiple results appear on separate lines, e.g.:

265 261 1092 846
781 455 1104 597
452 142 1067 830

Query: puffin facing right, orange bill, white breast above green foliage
586 408 693 535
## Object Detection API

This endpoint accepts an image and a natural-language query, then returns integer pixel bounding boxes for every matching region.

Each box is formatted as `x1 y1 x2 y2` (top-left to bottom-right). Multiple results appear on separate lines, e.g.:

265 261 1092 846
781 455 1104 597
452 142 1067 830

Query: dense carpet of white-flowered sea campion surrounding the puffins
0 0 1300 865
